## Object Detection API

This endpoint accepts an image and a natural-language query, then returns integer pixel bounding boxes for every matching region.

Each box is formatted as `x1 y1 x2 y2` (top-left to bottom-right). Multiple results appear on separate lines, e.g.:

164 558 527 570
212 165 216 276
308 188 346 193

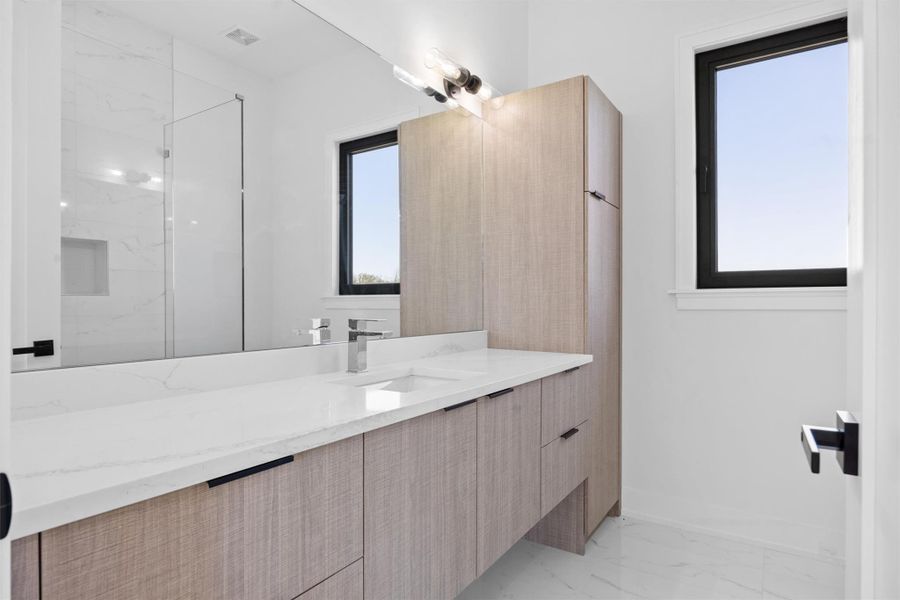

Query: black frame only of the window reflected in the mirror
338 129 400 296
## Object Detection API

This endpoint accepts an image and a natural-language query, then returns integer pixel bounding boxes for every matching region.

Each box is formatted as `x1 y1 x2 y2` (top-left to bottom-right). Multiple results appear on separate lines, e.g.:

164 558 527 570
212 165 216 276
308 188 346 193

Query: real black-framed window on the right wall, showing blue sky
695 19 849 288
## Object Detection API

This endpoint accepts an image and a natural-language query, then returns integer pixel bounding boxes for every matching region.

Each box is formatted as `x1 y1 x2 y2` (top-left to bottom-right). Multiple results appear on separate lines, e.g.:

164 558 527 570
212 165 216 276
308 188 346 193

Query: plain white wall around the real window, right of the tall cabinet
528 0 846 555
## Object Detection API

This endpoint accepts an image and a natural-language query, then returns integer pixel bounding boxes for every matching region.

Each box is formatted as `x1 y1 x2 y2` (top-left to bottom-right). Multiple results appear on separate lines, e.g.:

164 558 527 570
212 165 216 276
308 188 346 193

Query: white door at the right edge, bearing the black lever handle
846 0 900 598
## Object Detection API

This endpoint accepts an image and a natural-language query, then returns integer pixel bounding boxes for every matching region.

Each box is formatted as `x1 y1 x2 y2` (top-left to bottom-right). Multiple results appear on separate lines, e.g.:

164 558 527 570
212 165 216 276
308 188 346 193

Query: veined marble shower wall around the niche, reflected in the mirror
61 2 173 366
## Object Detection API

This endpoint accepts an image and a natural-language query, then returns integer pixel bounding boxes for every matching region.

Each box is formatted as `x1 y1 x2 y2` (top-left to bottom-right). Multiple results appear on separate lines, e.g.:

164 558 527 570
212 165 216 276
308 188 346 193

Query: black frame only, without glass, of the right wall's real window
694 18 847 288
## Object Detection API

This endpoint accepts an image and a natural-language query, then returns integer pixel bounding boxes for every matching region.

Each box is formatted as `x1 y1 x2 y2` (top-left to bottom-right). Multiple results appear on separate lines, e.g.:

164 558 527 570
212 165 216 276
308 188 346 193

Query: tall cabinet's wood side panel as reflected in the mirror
399 111 482 336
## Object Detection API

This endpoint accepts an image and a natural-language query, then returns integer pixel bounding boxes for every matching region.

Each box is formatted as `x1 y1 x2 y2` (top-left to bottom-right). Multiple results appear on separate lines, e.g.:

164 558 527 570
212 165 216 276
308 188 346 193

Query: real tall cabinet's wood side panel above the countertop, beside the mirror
484 77 585 352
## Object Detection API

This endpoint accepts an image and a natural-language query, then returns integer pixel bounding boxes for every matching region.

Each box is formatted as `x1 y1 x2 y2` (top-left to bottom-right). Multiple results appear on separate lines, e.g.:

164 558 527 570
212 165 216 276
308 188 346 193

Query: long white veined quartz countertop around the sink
11 349 592 538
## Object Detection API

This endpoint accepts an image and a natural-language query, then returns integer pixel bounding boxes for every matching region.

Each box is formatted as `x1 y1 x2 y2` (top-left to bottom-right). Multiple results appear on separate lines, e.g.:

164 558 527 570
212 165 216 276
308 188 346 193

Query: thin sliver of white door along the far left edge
0 2 13 598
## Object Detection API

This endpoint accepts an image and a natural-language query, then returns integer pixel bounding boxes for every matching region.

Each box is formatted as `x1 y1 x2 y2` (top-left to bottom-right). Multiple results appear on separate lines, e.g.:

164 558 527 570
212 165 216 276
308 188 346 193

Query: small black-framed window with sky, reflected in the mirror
339 131 400 295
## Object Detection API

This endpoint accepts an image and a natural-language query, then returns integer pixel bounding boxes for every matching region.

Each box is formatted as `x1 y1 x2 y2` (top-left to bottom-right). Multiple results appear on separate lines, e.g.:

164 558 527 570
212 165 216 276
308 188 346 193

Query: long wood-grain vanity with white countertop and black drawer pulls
13 342 591 600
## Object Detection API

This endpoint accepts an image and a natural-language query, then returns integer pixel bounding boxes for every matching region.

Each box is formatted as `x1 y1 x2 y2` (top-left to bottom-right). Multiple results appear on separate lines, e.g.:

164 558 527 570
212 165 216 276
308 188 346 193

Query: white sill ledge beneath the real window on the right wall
669 287 847 310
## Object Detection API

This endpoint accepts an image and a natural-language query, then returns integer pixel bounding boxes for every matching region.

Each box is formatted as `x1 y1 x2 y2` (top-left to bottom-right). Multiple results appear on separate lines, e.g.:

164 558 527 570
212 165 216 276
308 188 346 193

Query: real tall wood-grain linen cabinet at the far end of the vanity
484 77 621 534
